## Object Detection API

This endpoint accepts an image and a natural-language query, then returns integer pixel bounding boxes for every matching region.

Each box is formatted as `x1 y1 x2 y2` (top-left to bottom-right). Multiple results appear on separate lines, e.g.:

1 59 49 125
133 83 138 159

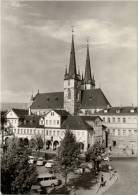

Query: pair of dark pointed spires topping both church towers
65 31 95 87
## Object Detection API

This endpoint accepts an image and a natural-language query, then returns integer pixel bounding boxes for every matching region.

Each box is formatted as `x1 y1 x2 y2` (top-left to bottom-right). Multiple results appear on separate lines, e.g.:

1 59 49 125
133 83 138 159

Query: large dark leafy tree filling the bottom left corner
1 138 37 194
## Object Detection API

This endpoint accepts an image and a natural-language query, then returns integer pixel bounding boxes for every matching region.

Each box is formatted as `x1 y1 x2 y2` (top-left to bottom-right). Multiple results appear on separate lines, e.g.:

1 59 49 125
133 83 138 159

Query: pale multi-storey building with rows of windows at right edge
97 107 138 153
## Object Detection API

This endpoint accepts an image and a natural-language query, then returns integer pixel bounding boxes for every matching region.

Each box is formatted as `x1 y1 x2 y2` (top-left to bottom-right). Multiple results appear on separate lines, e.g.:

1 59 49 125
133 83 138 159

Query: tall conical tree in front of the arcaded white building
56 130 80 185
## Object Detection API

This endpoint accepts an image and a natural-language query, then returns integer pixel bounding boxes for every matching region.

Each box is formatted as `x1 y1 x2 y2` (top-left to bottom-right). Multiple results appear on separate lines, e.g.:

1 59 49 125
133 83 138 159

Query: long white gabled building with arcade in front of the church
13 110 106 151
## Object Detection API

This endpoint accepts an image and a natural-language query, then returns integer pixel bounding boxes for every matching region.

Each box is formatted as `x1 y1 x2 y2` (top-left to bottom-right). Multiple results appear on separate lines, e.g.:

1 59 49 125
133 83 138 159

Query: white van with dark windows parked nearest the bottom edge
38 173 61 187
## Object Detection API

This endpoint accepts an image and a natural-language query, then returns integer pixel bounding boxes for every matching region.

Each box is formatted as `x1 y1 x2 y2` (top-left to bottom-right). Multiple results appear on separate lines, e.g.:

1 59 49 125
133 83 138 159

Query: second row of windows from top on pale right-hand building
110 129 137 136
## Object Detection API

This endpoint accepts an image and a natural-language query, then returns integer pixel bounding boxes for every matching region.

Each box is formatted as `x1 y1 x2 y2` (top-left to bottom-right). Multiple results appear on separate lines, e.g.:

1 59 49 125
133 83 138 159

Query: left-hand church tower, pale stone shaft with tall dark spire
64 32 81 115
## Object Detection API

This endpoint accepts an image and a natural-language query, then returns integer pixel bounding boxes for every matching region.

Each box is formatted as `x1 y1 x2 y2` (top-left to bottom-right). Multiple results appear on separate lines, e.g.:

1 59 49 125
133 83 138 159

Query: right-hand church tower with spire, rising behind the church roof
83 42 95 90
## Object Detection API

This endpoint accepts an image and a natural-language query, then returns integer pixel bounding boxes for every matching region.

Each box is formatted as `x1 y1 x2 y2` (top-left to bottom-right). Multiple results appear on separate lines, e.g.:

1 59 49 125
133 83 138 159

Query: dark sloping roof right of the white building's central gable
61 116 97 130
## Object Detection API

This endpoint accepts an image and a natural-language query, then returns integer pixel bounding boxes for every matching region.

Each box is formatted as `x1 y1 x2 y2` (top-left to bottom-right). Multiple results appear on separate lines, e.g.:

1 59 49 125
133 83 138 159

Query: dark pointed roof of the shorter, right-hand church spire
84 41 92 83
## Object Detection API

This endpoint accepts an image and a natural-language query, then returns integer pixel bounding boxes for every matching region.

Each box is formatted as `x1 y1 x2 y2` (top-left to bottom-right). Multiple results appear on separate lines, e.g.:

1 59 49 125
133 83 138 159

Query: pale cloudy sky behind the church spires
1 0 137 106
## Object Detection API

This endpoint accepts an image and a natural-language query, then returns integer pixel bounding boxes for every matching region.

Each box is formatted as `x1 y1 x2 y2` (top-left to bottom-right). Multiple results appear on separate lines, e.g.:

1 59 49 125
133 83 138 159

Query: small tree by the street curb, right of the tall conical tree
86 141 105 171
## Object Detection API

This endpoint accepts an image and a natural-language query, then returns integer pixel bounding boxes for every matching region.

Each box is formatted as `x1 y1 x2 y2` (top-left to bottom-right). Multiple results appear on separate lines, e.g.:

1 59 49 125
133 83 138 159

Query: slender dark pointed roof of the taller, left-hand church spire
69 30 77 78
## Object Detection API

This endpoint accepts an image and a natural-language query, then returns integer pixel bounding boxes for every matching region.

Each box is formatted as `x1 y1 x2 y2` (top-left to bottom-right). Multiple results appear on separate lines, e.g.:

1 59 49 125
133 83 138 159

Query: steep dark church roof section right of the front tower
81 88 110 109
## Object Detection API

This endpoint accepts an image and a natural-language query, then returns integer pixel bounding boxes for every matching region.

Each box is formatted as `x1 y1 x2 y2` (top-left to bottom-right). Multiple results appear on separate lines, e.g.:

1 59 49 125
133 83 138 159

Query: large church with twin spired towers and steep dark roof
29 34 111 115
